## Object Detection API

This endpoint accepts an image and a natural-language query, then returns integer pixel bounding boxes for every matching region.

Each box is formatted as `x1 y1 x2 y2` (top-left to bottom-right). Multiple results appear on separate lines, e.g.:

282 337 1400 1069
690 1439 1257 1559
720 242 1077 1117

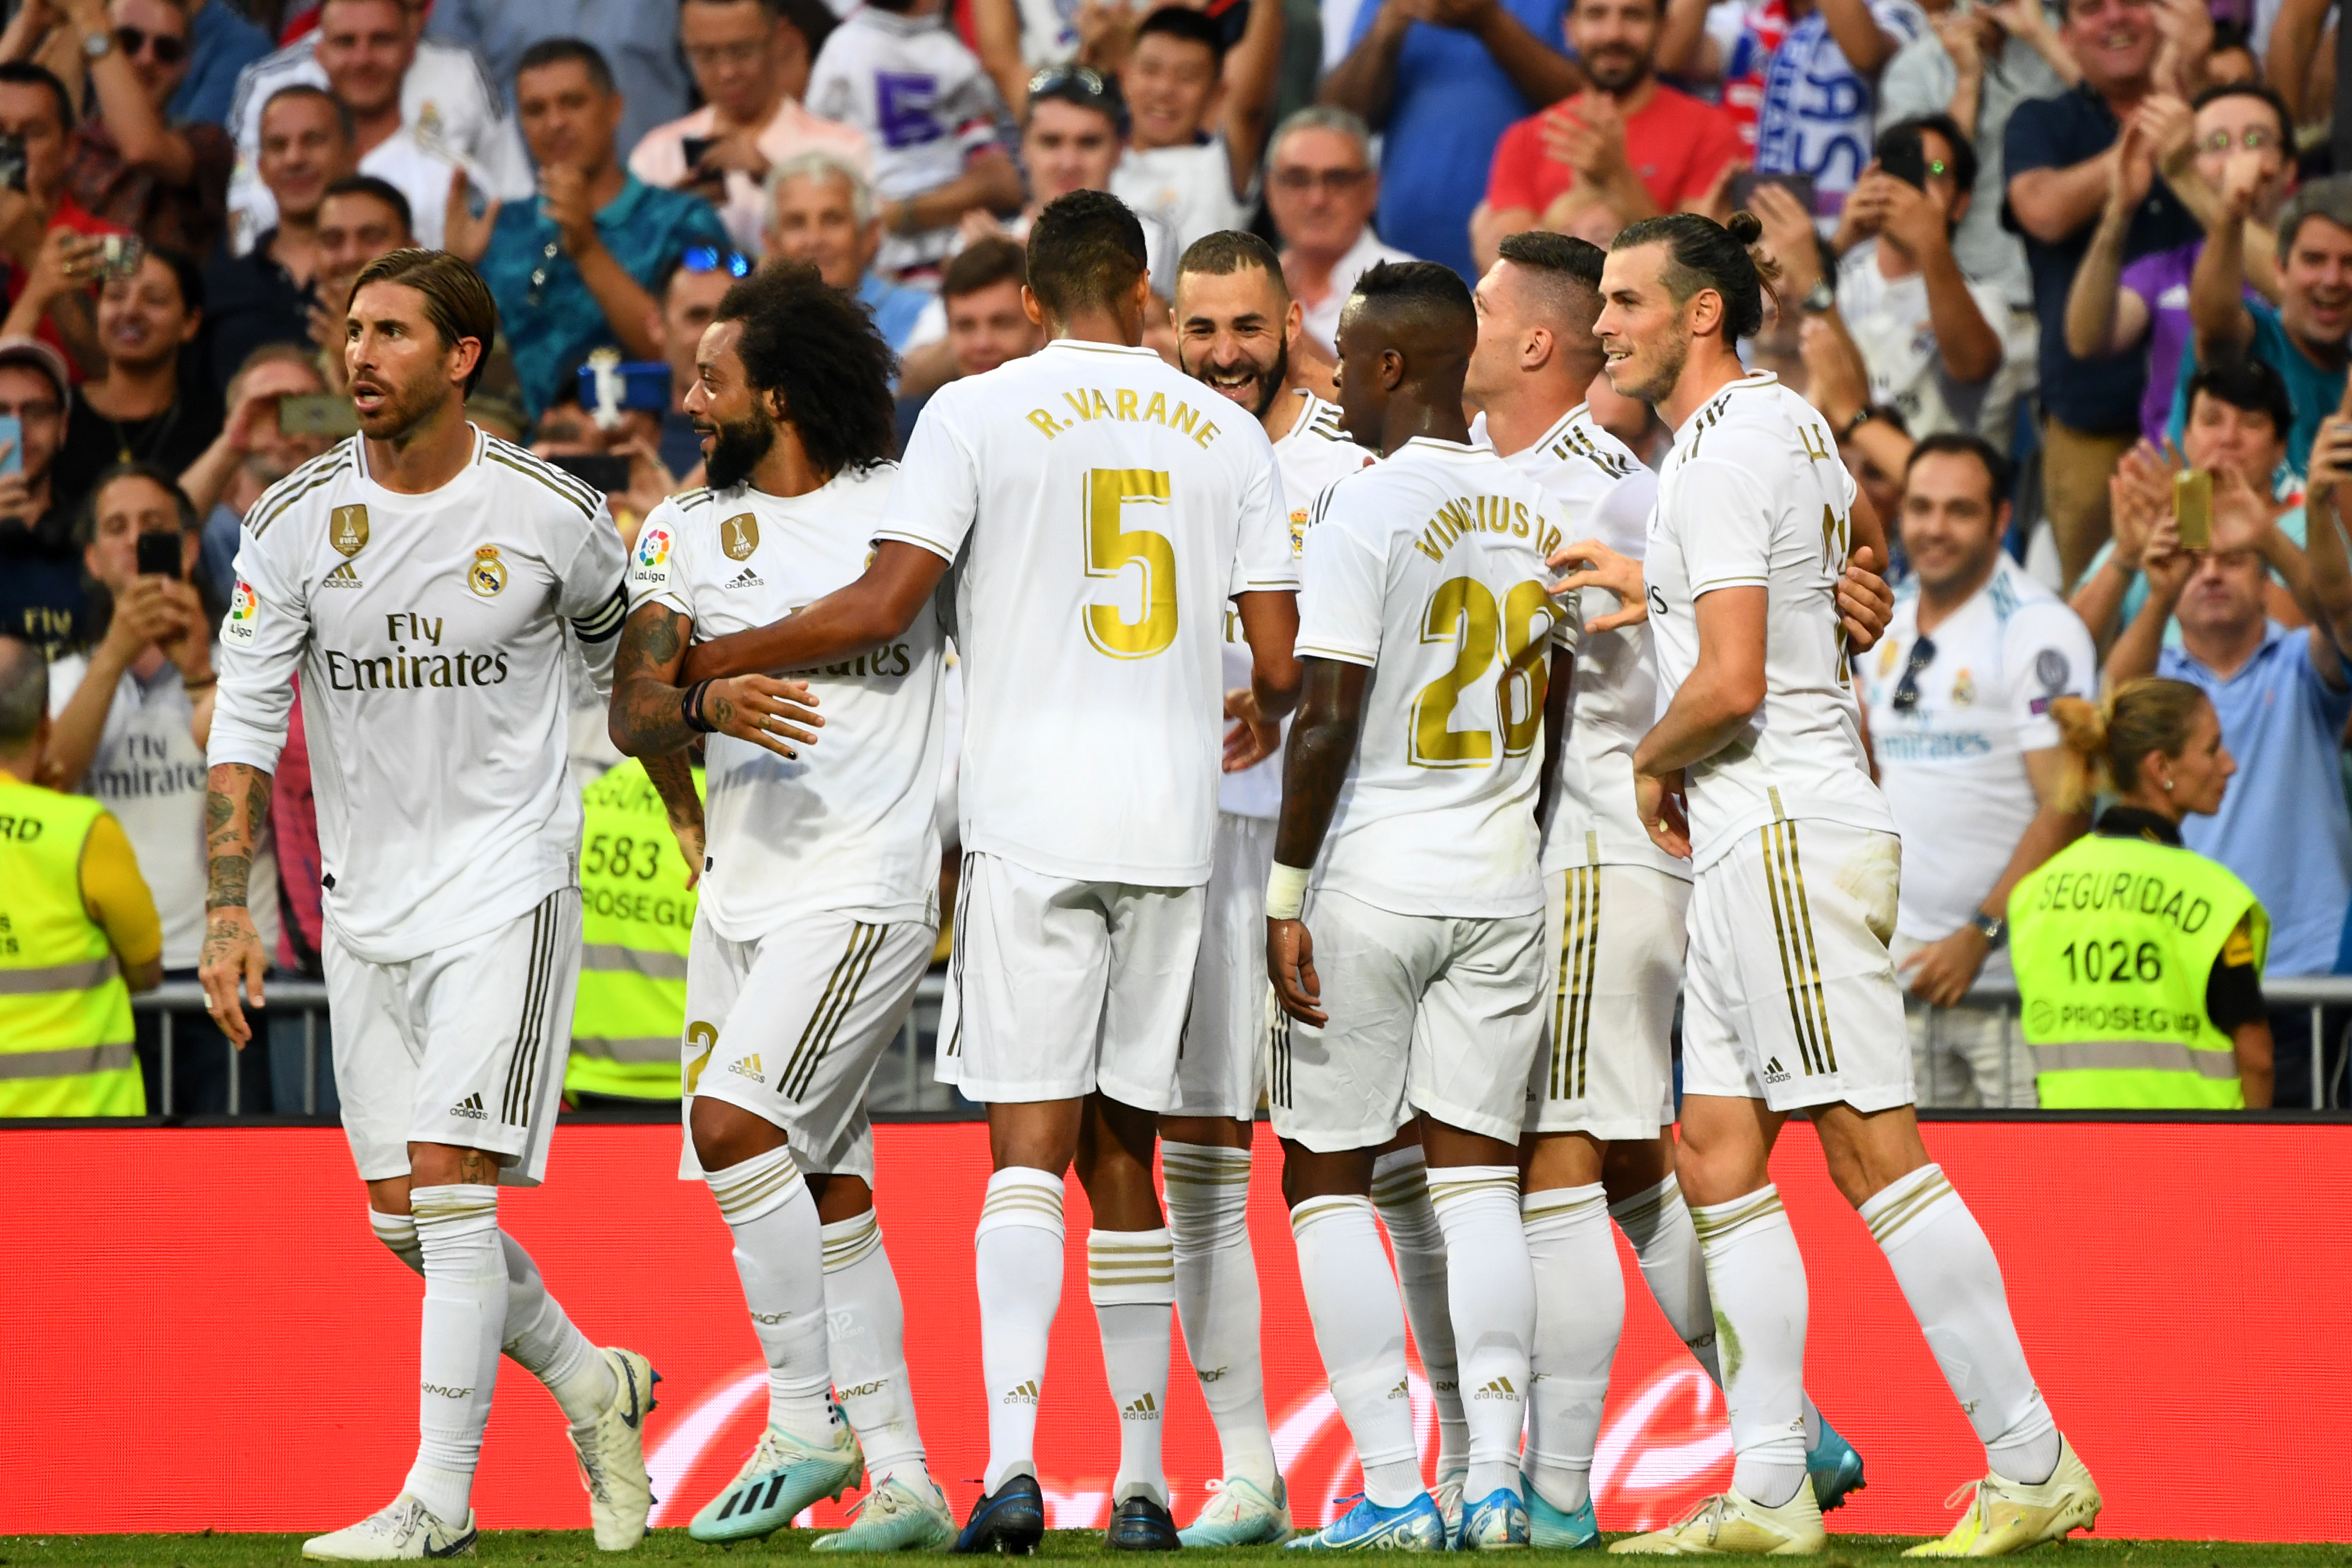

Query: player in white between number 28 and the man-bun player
1463 230 1863 1547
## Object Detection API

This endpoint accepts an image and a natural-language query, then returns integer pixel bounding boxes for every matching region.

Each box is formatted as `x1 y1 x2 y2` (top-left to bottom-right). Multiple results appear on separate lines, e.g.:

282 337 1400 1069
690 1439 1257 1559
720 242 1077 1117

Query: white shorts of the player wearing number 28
1266 889 1550 1154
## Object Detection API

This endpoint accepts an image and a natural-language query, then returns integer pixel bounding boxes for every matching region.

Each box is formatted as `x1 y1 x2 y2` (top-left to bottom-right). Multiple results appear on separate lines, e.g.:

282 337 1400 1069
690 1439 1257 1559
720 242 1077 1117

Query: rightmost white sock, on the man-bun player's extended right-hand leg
1863 1166 2058 1486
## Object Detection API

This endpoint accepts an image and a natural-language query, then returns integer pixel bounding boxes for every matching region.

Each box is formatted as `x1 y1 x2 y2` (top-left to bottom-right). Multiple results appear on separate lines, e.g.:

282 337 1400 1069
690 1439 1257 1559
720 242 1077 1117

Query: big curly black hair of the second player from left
710 259 898 475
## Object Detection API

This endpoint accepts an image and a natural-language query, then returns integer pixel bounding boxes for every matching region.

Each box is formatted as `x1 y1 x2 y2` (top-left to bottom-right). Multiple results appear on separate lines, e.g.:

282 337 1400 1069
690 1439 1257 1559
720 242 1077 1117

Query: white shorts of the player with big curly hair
678 910 939 1185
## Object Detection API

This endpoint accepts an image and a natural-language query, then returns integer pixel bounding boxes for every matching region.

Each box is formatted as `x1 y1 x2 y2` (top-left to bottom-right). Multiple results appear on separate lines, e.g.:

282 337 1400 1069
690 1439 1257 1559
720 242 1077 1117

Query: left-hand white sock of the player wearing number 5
972 1166 1063 1493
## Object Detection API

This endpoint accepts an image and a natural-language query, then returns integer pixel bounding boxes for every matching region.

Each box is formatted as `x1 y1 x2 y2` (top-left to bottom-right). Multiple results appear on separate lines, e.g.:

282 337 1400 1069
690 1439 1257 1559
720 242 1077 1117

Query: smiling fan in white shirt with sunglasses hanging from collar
1856 433 2098 1105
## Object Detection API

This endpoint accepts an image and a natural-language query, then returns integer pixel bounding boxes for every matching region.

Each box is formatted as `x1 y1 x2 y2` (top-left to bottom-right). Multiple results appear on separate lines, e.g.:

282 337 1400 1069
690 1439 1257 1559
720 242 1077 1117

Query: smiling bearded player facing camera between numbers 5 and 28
1160 230 1374 1547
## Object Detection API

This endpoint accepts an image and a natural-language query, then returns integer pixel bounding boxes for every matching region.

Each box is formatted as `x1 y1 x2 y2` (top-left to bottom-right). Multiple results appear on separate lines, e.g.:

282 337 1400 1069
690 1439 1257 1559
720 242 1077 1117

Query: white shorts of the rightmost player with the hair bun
1682 818 1912 1112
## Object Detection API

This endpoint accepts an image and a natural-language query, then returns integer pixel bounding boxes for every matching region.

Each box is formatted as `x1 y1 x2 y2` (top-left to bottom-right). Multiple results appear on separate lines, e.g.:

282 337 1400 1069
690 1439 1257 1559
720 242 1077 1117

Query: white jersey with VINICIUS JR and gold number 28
1298 437 1573 917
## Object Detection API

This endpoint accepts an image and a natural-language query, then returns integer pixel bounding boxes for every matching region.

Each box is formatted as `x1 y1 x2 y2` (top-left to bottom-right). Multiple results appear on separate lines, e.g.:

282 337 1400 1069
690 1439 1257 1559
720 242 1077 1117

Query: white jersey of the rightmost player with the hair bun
1642 371 1896 870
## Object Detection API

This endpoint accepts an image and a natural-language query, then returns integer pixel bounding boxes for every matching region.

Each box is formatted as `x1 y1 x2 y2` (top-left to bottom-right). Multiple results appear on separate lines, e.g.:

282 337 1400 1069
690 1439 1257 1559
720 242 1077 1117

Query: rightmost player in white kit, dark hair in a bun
1595 214 2100 1556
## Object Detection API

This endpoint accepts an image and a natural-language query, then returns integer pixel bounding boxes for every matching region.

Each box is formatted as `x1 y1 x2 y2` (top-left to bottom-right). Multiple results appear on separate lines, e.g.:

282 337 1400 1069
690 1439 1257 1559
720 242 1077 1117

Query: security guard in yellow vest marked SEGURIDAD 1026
2009 679 2270 1110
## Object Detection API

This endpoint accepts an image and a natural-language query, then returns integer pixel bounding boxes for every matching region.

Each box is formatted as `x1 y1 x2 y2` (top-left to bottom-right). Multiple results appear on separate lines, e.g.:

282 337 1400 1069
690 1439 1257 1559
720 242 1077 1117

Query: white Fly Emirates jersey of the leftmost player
210 430 628 964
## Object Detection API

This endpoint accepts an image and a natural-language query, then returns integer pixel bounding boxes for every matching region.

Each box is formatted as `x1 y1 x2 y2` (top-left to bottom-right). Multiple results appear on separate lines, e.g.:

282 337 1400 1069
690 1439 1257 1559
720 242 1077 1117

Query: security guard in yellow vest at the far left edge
0 637 162 1116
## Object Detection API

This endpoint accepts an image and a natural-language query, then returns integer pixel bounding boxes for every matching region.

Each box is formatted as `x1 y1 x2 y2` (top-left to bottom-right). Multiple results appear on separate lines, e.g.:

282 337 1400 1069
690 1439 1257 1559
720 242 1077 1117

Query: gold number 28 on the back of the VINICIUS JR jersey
1407 576 1552 769
